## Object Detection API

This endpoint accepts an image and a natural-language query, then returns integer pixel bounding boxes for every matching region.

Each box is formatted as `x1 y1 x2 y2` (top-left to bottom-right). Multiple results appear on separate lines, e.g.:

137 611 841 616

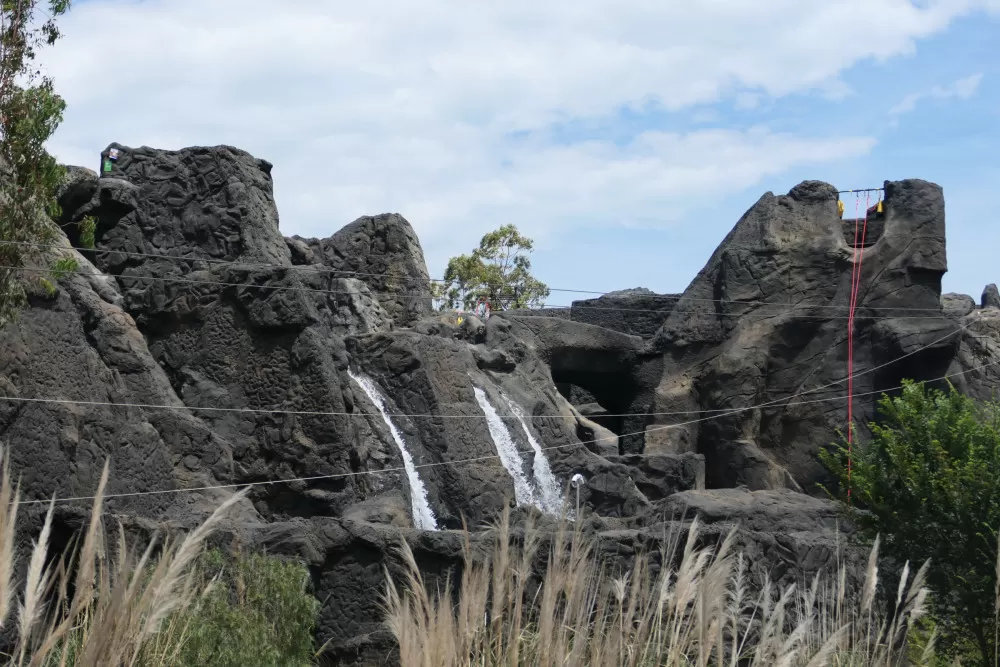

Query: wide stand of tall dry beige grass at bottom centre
385 512 934 667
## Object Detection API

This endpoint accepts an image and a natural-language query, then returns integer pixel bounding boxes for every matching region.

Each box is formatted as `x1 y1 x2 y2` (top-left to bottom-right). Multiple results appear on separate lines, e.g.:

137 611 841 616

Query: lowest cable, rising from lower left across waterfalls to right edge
9 359 1000 505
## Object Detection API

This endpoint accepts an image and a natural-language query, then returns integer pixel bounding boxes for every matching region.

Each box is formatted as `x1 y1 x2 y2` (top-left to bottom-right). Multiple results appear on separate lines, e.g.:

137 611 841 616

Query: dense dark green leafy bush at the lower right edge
820 382 1000 665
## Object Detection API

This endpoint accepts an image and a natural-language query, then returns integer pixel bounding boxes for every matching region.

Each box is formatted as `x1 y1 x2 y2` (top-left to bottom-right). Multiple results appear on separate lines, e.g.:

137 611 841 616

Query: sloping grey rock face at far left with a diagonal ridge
0 246 256 524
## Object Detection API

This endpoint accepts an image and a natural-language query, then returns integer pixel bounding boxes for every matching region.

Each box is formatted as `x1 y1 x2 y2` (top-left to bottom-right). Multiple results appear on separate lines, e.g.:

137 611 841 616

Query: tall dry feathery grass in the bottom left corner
0 448 245 667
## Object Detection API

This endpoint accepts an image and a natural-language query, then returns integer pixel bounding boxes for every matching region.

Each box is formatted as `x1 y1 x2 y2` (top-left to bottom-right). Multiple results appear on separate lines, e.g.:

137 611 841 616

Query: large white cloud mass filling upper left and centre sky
45 0 993 271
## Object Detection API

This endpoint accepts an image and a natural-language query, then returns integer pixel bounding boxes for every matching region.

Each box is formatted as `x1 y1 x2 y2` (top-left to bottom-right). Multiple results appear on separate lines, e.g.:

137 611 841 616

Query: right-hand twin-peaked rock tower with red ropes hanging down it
646 180 959 491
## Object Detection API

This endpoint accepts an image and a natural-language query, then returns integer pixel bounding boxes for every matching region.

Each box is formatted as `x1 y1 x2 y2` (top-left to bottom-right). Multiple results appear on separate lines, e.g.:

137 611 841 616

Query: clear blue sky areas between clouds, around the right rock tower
534 15 1000 301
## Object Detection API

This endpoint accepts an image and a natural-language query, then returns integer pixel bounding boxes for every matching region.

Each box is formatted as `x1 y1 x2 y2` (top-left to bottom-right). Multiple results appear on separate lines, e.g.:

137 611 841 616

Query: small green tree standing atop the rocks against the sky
435 225 549 311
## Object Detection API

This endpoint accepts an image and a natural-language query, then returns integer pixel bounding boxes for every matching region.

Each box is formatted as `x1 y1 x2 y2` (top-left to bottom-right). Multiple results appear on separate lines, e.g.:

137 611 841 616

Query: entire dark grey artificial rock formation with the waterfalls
0 144 1000 663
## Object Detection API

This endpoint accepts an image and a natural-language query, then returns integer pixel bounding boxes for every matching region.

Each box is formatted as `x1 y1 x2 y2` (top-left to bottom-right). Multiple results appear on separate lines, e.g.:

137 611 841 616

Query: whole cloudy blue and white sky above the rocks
35 0 1000 305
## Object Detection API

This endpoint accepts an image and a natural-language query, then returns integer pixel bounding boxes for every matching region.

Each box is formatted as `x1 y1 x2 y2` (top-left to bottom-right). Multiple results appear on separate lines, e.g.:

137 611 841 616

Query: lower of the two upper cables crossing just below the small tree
0 265 972 320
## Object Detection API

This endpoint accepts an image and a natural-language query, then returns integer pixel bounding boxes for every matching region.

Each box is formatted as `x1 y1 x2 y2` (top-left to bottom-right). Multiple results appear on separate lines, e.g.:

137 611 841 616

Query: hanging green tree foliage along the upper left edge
0 0 70 326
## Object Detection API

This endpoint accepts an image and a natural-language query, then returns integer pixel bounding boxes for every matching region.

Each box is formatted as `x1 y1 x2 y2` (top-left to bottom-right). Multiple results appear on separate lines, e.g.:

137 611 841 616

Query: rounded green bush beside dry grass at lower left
164 550 319 667
